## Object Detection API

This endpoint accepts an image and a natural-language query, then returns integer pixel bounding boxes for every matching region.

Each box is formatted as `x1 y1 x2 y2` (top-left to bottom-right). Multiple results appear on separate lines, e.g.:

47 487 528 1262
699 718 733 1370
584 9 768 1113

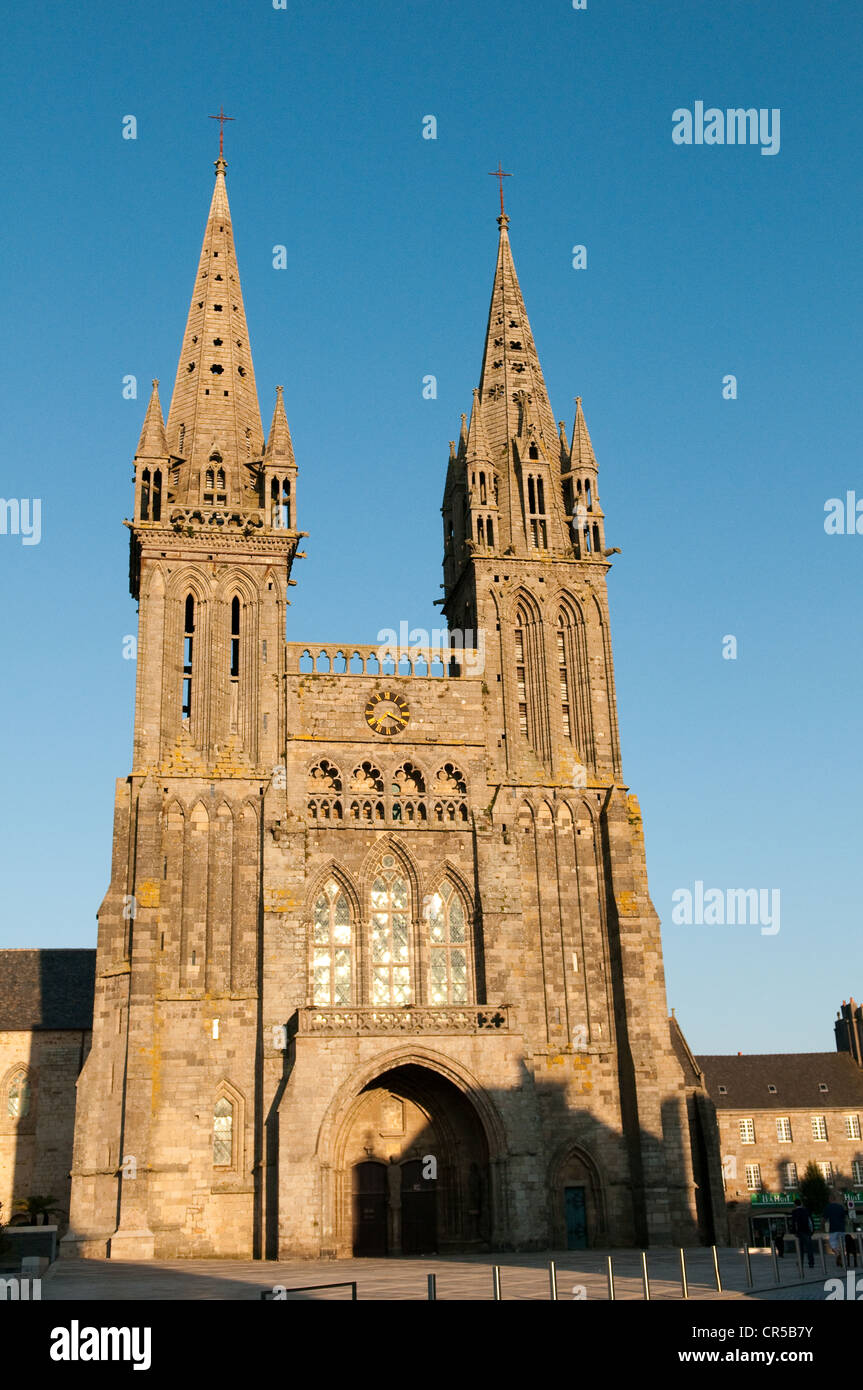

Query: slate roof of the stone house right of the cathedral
696 1052 863 1112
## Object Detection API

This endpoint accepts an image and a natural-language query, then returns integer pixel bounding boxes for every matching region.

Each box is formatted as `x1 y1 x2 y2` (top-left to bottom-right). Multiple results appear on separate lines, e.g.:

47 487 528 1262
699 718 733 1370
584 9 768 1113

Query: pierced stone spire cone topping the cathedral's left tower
167 154 264 506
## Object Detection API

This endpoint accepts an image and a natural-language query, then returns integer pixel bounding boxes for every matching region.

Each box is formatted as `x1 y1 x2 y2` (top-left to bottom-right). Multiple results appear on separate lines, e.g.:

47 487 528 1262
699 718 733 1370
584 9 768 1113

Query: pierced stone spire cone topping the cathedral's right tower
479 213 559 455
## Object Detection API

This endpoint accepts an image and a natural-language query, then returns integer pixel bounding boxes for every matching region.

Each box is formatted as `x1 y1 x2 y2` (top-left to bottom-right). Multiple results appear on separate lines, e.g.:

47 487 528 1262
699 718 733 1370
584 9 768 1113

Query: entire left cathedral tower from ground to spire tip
65 138 303 1258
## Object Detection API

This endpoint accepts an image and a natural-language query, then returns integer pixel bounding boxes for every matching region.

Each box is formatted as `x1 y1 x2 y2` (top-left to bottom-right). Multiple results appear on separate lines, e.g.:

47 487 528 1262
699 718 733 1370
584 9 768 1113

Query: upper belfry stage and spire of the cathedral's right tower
442 213 620 785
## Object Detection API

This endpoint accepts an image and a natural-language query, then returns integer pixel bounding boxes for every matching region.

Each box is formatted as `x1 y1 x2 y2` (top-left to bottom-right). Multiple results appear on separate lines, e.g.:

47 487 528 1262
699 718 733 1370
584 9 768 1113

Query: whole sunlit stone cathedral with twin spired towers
63 149 723 1259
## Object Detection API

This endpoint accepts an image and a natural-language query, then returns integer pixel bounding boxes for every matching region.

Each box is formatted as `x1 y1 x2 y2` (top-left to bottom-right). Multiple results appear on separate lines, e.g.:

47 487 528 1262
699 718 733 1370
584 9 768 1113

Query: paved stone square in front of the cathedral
42 1248 837 1302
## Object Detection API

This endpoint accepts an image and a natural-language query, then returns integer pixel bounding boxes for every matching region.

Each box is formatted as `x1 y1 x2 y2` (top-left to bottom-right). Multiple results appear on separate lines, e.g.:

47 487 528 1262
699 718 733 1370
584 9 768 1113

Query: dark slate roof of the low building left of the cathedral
0 948 96 1033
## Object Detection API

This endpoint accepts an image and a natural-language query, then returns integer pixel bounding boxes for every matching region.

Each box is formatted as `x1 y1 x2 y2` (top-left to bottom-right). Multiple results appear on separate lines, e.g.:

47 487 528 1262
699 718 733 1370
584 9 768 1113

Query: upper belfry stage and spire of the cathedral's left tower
129 154 299 771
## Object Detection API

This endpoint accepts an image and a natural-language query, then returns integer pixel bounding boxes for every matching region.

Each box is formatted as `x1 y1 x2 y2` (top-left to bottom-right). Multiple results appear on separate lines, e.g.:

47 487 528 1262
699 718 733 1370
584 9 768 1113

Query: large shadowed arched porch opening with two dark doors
339 1063 491 1255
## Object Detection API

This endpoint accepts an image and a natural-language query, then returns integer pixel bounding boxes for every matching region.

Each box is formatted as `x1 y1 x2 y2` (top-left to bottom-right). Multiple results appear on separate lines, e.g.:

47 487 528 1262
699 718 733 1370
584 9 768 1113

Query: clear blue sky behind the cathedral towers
0 0 863 1052
